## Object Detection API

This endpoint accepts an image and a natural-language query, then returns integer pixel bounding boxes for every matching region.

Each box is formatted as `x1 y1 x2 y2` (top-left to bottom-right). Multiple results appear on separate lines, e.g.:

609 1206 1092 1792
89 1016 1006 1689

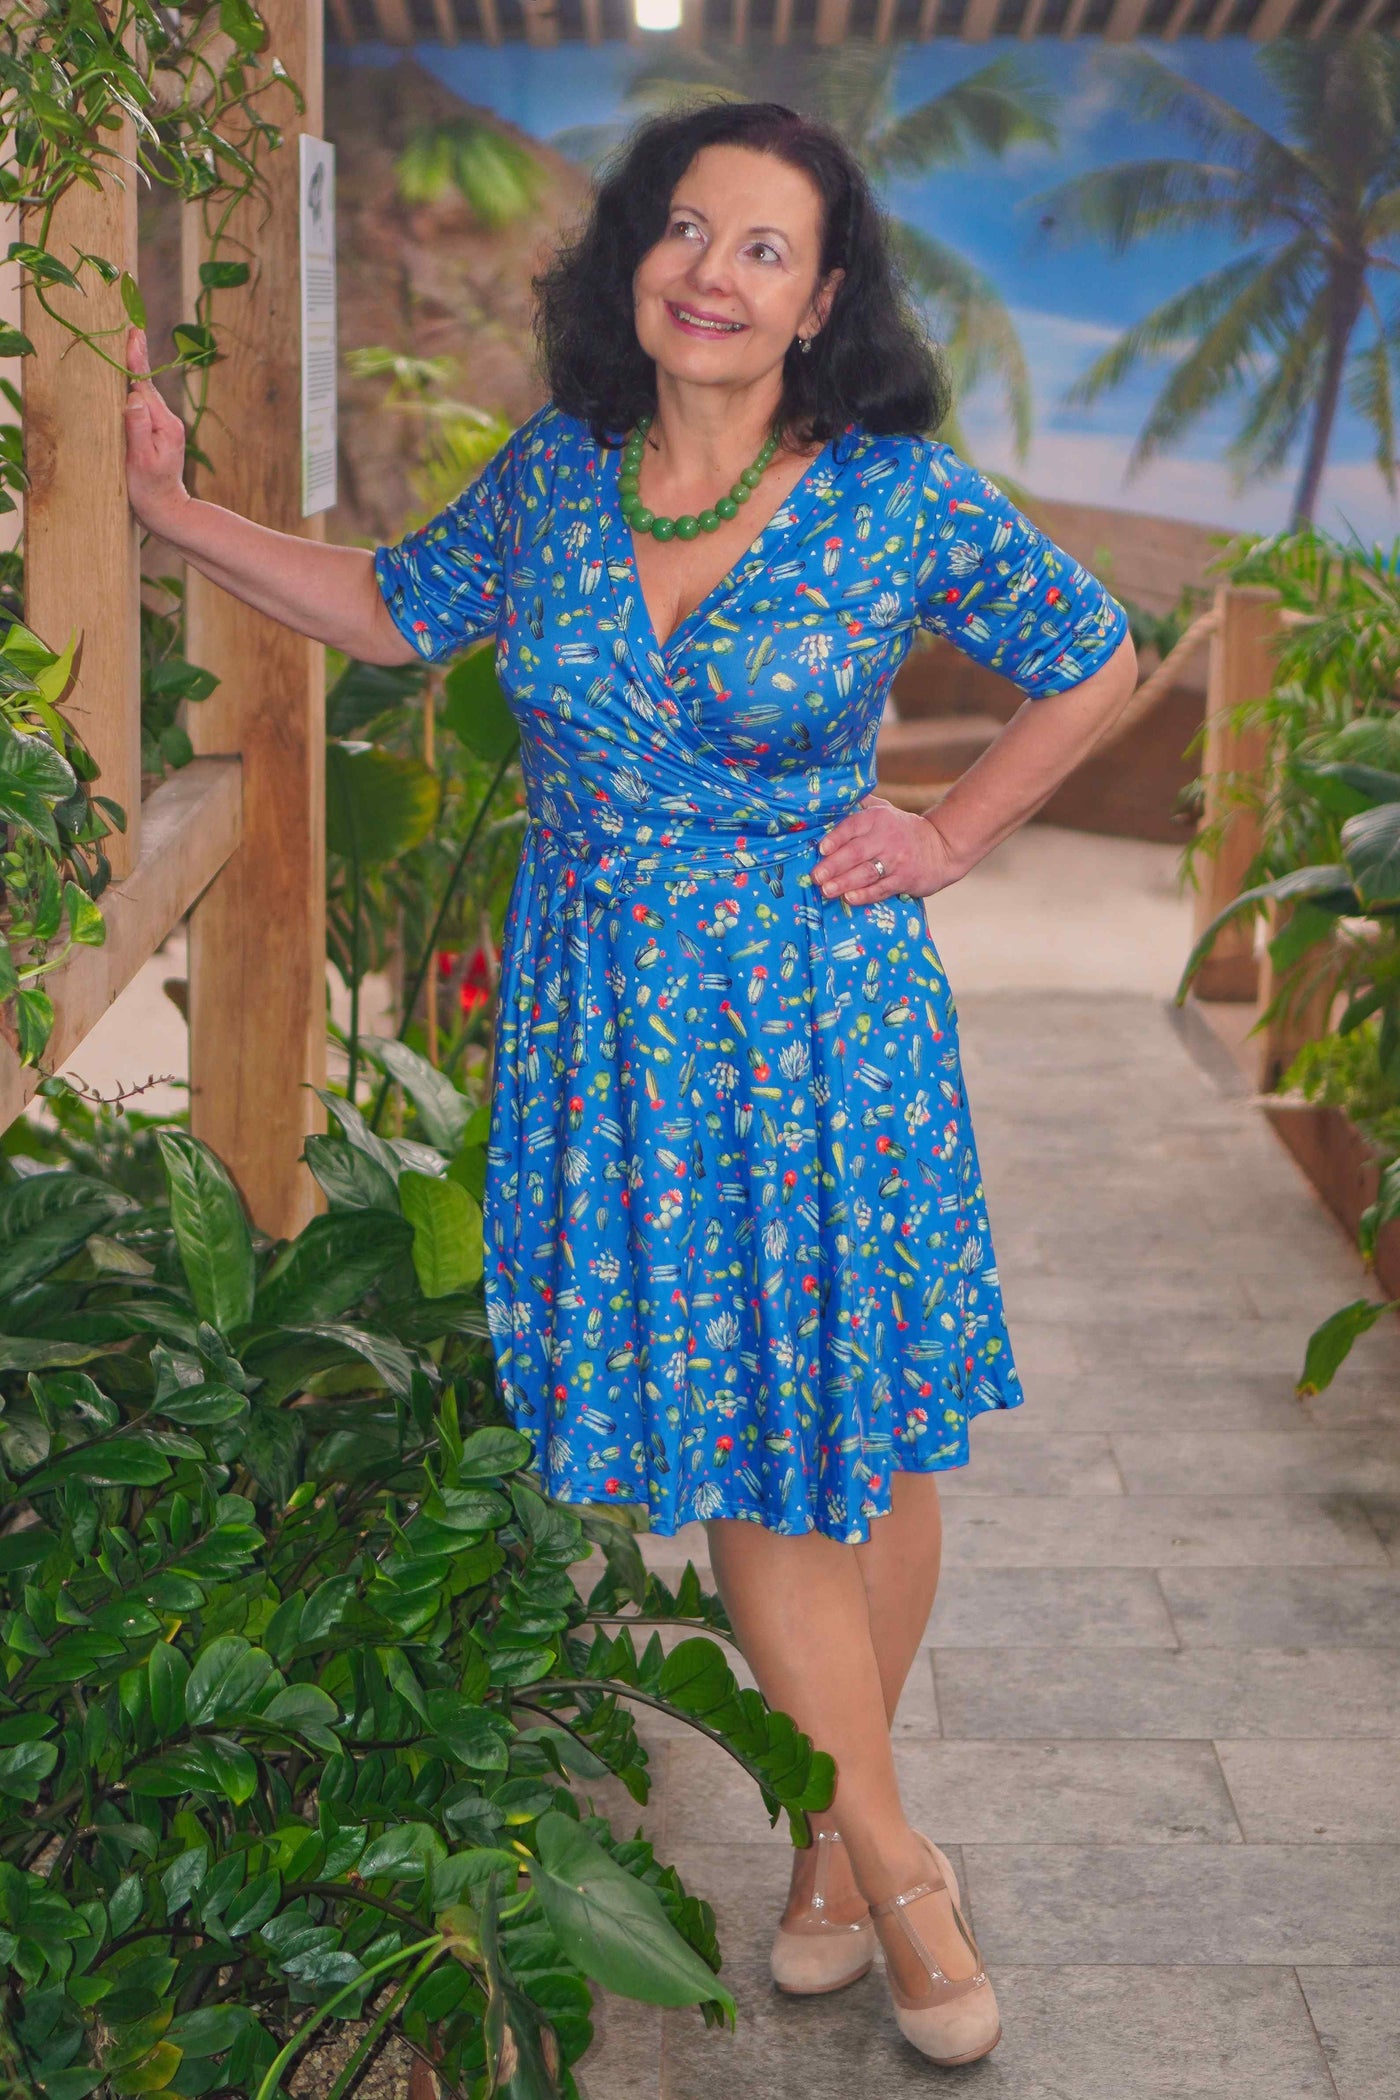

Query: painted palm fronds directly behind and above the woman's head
554 38 1056 458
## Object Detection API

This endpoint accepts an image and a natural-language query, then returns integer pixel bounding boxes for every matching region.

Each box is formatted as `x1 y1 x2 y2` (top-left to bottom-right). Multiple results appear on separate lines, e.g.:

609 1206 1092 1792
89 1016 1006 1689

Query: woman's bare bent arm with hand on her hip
816 636 1138 905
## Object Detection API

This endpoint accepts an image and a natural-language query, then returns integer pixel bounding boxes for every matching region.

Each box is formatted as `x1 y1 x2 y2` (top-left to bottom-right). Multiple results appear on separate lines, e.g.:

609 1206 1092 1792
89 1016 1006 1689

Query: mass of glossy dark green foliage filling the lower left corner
0 1100 833 2100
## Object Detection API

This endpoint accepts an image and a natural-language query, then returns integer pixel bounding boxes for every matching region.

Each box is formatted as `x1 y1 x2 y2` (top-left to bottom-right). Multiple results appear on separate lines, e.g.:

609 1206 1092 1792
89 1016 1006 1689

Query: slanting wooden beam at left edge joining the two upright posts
0 758 243 1130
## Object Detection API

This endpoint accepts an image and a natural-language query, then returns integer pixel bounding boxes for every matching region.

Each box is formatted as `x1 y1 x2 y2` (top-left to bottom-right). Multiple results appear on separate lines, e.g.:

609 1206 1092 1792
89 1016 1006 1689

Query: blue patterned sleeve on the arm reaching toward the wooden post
374 439 514 664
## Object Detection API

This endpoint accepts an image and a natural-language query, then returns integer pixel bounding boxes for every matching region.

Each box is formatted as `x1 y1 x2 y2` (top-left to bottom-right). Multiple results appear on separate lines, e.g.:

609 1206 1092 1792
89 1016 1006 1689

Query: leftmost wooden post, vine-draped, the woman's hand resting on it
21 104 141 878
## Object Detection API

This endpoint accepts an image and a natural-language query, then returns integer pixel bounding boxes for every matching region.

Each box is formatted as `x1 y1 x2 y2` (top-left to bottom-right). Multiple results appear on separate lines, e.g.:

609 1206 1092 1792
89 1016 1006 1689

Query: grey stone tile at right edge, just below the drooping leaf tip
1112 1428 1400 1495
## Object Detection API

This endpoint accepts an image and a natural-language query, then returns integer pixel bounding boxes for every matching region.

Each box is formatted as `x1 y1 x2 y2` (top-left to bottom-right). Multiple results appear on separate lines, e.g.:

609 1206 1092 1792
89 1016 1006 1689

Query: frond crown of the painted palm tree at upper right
1035 34 1400 527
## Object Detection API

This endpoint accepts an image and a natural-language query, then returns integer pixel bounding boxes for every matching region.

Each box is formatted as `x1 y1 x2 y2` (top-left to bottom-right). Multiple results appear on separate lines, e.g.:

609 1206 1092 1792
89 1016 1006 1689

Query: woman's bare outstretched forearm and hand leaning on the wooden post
126 328 416 664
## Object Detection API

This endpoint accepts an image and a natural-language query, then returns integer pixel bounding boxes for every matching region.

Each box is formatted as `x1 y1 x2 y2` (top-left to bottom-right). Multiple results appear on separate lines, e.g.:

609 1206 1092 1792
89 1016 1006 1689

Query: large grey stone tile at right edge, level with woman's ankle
966 1844 1400 1965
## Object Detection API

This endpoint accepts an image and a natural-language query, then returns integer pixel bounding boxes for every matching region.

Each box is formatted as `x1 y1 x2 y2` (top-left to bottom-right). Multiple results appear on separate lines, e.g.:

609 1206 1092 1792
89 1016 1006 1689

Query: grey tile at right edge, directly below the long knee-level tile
1167 1569 1400 1649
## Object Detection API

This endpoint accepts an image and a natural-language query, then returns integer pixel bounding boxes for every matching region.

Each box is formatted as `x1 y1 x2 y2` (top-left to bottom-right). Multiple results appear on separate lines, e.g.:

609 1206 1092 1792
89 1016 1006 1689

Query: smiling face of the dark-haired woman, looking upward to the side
632 145 840 386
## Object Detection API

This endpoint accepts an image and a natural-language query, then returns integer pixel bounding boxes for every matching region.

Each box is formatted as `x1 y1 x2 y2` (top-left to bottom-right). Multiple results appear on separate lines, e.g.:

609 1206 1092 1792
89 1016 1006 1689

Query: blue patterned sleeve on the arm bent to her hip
915 445 1127 699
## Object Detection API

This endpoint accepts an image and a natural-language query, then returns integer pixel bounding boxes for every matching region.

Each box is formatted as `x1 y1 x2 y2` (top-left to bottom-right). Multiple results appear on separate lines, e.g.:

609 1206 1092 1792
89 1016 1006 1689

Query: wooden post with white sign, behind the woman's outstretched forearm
185 0 325 1235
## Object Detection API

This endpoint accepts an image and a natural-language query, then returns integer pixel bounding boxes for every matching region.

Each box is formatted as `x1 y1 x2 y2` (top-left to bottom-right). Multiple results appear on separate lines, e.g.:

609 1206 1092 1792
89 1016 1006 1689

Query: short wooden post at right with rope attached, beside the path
1196 584 1280 1002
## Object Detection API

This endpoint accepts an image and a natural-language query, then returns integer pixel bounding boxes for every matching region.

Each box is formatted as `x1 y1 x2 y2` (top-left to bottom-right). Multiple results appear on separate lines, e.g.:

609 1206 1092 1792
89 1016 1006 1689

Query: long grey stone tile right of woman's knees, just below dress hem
945 1495 1385 1567
